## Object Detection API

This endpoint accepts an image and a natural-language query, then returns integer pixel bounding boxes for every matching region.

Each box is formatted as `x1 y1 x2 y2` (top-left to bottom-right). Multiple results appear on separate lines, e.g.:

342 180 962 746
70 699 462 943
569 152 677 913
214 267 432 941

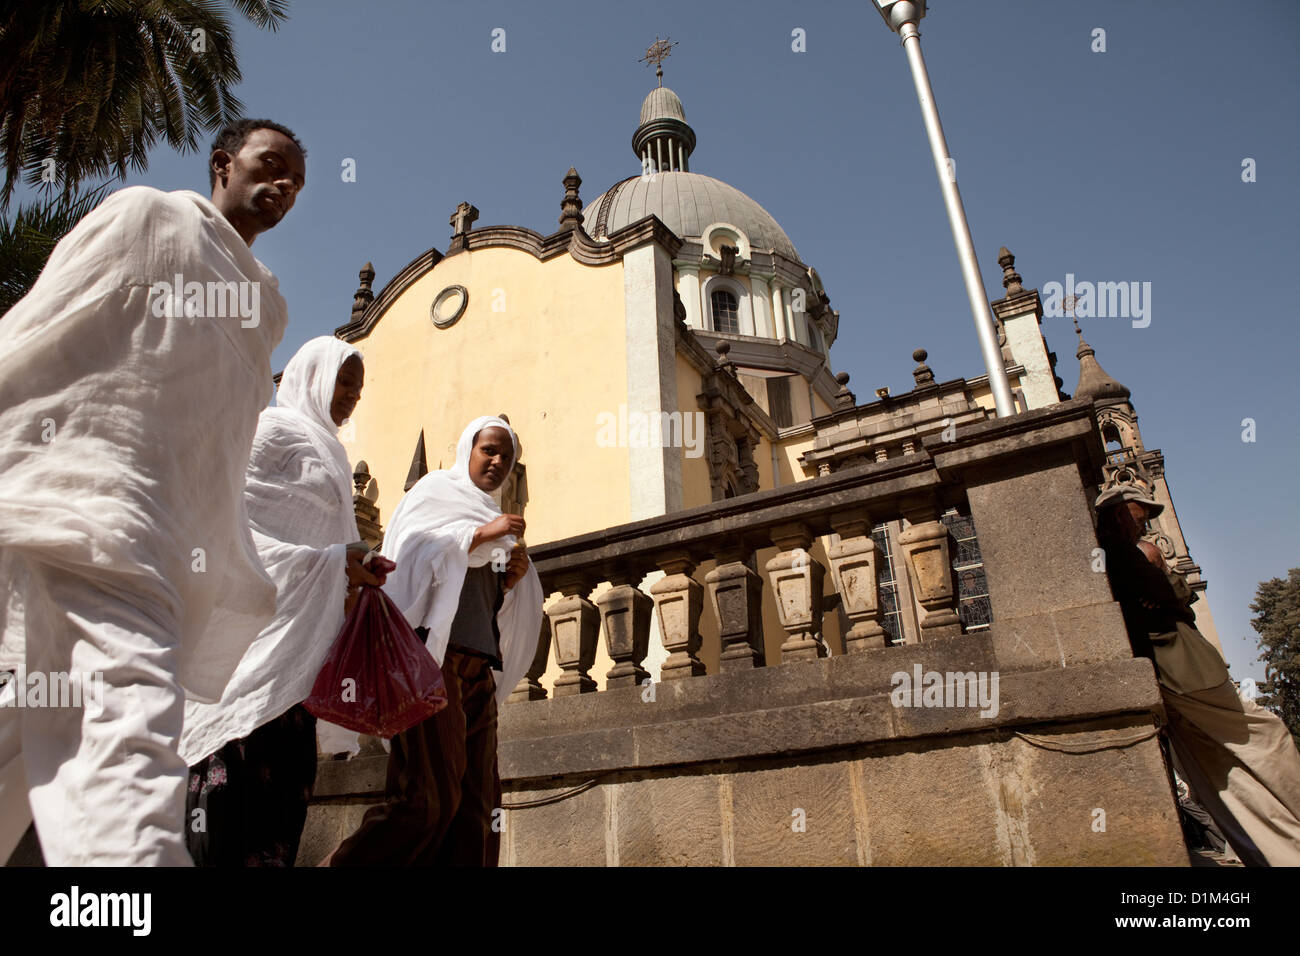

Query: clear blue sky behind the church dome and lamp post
35 0 1300 678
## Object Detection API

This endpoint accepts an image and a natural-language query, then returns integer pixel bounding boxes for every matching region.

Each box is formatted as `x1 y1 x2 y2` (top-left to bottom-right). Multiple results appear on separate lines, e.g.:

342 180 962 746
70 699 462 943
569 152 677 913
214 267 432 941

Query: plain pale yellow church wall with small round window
341 248 629 542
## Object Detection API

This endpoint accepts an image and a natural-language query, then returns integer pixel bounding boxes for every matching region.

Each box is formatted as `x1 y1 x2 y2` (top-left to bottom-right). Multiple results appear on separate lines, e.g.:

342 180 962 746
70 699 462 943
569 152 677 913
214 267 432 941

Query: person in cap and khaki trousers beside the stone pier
1096 485 1300 866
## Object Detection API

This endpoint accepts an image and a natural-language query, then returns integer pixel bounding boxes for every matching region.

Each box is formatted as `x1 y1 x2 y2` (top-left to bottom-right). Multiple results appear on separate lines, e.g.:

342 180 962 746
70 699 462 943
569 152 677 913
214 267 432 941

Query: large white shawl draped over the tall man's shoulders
0 186 287 700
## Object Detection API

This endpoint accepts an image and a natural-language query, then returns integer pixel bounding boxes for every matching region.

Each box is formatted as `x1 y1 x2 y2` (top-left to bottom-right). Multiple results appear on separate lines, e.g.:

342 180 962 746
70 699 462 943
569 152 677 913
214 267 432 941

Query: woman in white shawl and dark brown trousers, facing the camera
330 416 543 866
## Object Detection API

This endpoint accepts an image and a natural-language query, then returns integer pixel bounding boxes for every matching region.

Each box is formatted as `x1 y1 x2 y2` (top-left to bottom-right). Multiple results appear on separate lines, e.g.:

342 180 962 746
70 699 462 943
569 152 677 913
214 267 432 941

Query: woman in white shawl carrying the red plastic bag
181 336 382 866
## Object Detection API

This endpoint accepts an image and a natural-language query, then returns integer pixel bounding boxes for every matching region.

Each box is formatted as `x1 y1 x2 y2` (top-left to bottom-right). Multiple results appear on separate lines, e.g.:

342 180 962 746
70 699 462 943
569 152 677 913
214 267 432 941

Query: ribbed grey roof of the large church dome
582 172 803 263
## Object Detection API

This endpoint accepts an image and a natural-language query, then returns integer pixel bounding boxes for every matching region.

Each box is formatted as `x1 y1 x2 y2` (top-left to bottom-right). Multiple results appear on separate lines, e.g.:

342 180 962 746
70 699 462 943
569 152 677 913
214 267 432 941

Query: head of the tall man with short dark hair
212 129 307 242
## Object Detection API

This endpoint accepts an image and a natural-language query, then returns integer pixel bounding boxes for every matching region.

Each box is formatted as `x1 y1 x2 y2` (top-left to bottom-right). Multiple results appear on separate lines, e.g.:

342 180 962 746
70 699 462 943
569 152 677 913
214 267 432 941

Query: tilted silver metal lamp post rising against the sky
874 0 1015 419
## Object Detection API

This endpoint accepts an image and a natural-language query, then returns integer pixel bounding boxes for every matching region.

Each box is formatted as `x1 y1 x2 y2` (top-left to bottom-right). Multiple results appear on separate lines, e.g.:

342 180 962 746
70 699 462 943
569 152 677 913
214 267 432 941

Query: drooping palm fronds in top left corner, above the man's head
0 0 289 206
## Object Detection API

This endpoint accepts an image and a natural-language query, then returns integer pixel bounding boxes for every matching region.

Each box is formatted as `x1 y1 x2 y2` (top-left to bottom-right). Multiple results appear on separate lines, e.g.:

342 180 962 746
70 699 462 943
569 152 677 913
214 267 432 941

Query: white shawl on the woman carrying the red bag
179 336 360 763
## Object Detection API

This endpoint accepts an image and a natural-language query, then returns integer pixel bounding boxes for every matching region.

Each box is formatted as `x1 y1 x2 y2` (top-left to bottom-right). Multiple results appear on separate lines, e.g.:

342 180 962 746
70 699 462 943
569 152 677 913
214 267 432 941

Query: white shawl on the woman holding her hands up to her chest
382 416 543 705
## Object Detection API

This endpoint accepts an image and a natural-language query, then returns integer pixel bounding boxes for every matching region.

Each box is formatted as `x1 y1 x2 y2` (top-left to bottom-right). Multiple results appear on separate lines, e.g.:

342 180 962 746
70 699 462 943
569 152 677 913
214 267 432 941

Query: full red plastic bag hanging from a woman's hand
303 555 447 737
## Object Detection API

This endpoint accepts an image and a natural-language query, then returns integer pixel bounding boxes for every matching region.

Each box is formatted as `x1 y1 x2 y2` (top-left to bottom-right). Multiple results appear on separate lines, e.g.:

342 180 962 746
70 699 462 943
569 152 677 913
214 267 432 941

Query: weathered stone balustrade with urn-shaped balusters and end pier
510 401 1109 702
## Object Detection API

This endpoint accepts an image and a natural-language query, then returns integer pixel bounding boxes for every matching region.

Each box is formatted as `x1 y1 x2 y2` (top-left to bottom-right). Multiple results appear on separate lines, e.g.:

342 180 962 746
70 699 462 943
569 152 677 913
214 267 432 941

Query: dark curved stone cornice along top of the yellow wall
334 216 681 342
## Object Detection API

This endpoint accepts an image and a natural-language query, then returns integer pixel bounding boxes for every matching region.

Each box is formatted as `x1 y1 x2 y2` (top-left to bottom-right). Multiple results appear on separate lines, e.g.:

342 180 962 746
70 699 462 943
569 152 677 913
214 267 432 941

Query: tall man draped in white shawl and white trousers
0 120 306 865
